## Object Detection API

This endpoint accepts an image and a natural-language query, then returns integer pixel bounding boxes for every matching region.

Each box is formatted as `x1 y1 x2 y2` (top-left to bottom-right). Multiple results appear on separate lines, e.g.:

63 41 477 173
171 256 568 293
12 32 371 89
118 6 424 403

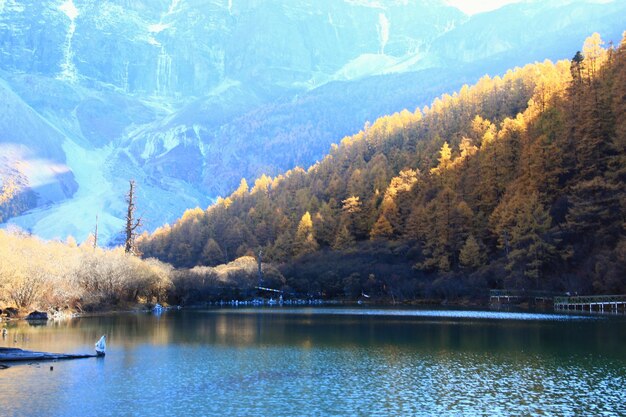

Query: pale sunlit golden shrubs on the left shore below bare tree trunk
0 230 173 316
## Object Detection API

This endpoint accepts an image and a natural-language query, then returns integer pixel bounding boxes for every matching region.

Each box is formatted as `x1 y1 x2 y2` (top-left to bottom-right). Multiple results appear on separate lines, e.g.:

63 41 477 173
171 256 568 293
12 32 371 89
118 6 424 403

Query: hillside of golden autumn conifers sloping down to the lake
140 34 626 299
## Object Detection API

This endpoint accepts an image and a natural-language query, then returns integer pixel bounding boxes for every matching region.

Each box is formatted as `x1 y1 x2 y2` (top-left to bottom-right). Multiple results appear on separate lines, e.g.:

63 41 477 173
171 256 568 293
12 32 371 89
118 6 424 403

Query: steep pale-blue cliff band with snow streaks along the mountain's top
0 0 463 97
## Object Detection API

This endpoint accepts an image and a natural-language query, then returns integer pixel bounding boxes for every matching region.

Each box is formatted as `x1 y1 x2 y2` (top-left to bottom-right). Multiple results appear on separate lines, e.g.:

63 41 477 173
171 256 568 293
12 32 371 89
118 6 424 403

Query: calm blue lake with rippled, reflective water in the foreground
0 307 626 417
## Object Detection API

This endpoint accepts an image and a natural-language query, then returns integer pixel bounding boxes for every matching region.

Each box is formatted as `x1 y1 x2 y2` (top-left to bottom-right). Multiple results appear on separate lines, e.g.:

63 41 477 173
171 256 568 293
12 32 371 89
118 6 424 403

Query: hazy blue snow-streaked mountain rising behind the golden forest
0 0 626 241
